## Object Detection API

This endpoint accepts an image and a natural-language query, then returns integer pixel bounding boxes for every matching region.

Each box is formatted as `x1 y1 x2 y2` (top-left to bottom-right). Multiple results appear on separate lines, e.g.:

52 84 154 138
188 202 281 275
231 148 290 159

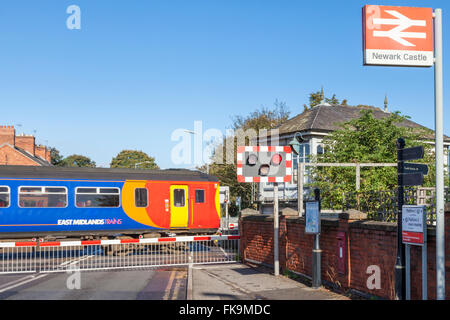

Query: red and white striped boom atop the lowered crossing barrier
0 235 240 248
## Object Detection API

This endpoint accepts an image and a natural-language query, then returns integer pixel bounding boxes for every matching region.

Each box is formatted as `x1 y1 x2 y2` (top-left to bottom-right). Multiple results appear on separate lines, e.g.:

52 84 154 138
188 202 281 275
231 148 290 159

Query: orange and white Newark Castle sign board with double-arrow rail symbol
363 5 434 67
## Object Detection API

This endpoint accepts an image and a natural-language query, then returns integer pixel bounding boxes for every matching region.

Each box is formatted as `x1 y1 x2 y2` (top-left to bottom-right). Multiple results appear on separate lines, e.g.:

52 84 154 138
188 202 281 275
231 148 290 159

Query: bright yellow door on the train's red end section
170 185 189 228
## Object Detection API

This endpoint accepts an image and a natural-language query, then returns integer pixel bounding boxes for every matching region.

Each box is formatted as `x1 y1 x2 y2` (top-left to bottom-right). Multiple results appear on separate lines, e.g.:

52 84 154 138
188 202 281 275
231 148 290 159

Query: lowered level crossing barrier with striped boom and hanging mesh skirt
0 235 240 274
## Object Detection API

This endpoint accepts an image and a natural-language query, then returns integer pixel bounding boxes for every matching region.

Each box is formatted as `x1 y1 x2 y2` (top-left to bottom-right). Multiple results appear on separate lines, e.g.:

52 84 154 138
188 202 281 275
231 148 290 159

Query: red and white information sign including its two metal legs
402 205 428 300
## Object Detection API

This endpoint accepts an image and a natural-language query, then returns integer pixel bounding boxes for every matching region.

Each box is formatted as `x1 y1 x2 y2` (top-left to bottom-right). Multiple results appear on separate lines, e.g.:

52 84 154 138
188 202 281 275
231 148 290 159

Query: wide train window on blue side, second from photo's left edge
19 187 67 208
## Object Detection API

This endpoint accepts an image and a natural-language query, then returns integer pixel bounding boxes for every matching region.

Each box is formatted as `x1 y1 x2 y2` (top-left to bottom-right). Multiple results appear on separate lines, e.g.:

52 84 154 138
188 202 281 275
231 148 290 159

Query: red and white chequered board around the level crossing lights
236 146 292 183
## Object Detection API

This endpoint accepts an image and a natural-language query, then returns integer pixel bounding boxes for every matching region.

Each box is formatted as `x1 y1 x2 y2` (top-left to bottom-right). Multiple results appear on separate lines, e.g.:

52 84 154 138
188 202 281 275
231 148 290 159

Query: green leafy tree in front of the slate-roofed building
311 108 434 209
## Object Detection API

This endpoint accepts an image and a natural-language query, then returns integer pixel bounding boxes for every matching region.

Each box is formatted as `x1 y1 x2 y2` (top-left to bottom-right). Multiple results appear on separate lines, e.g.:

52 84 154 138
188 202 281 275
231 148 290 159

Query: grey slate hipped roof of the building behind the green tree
270 104 450 142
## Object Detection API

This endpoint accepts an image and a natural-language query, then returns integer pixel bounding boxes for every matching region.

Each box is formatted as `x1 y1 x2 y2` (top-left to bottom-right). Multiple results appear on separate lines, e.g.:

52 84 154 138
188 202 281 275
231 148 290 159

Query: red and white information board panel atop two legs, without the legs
402 205 427 246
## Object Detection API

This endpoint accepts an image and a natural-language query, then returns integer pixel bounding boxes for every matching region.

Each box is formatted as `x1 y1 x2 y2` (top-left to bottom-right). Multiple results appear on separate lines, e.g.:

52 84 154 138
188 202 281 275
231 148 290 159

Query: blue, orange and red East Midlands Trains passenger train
0 166 220 239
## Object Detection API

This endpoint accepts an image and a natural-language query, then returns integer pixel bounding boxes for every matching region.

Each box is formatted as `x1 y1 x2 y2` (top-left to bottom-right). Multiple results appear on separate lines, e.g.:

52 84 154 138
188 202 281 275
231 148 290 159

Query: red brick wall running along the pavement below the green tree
239 203 450 299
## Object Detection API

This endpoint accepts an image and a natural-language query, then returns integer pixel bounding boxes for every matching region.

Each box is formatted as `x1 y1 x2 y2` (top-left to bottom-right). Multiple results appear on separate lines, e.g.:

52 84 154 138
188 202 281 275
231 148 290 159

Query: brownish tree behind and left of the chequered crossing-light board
209 100 290 215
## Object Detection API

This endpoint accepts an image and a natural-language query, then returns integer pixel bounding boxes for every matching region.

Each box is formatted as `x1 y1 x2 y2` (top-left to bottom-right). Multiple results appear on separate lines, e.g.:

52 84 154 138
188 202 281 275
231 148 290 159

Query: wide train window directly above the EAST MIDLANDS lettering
75 188 120 208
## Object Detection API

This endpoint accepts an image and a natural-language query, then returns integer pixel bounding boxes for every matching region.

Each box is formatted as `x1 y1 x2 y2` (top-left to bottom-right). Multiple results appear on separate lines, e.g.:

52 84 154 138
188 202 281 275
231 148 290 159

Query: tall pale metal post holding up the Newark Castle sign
434 9 445 300
